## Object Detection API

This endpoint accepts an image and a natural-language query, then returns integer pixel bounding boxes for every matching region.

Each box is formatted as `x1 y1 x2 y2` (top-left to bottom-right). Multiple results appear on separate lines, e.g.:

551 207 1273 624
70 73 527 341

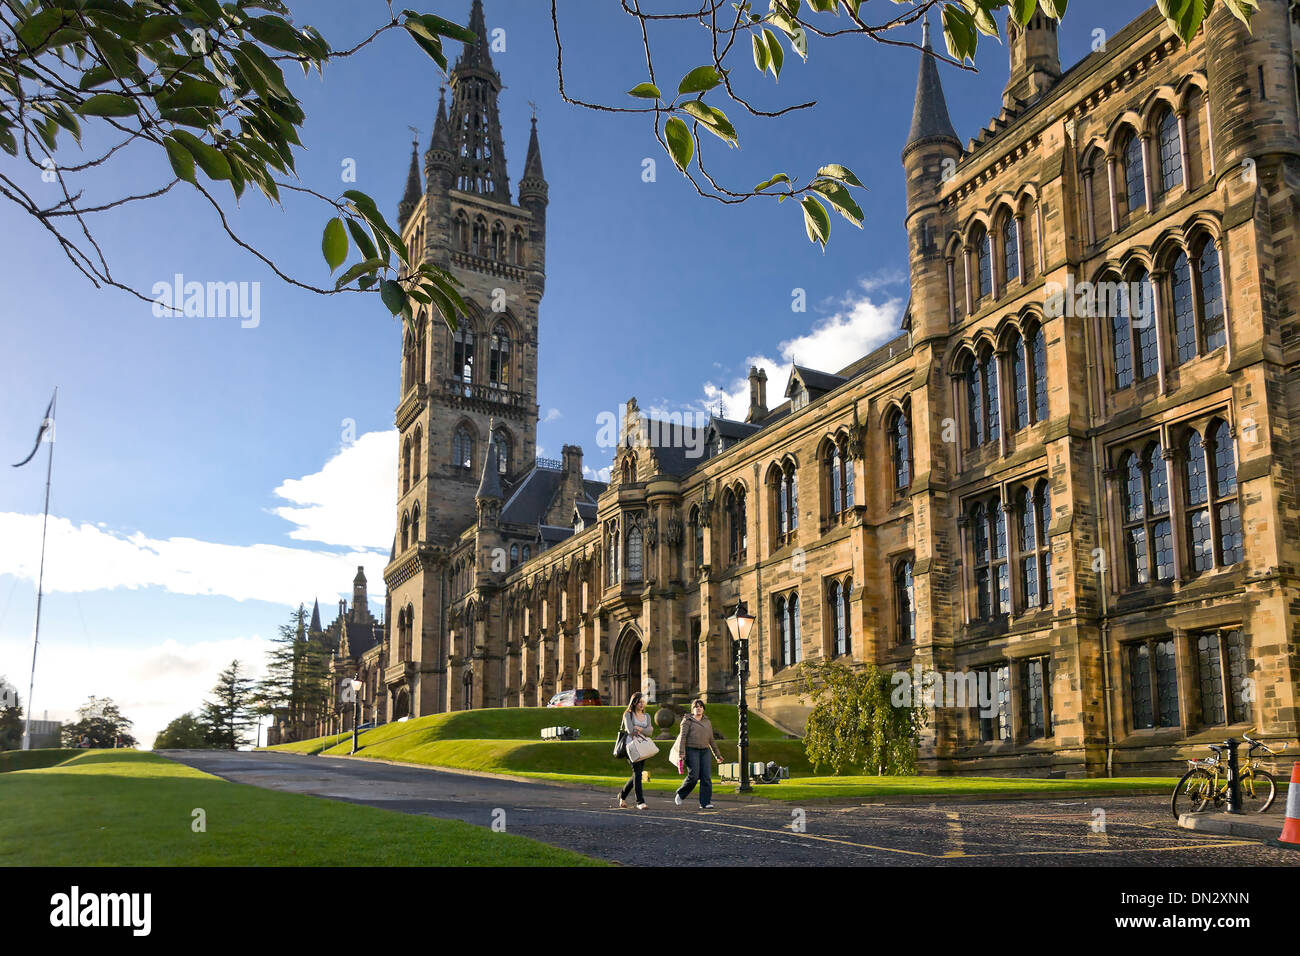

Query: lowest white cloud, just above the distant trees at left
0 636 270 747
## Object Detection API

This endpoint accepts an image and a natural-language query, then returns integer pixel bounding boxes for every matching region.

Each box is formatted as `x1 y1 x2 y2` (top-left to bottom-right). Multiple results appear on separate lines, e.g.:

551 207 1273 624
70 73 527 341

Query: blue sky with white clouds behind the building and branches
0 0 1139 744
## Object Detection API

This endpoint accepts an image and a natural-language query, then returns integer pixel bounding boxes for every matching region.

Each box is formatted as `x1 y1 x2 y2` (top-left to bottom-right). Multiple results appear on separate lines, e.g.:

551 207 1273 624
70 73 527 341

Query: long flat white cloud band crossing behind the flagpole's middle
0 512 387 606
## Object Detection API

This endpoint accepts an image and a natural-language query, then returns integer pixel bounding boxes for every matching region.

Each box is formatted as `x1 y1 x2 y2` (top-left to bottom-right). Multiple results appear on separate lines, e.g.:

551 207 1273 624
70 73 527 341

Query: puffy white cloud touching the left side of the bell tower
274 429 398 550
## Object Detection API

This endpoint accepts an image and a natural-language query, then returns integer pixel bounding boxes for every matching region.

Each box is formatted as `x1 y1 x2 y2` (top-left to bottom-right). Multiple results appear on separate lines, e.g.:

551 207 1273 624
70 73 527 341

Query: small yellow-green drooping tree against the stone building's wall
800 661 926 775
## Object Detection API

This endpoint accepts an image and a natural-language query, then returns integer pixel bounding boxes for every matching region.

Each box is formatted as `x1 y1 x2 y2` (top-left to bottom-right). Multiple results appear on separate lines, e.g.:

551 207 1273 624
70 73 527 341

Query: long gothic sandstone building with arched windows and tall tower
317 0 1300 774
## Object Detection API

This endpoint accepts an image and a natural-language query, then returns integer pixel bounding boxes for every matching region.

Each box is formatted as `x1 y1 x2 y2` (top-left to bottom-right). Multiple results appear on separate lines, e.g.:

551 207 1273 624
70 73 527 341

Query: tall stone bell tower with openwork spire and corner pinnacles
384 0 547 715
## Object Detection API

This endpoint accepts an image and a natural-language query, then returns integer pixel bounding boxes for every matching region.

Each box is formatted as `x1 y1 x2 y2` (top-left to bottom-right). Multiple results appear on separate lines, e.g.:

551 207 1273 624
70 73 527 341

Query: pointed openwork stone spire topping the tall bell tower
447 0 510 203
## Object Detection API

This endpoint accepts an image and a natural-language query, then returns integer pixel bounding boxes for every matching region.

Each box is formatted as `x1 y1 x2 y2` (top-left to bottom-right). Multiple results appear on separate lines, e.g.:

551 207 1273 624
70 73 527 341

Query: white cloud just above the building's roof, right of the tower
699 282 905 419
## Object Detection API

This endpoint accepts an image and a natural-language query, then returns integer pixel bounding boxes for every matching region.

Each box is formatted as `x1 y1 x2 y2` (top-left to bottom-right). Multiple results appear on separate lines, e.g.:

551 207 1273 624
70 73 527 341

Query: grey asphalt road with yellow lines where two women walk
164 750 1300 866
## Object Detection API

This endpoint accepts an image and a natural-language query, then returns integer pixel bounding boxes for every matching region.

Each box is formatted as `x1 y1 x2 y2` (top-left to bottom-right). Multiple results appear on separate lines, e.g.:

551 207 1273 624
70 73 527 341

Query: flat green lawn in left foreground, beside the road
0 750 602 866
